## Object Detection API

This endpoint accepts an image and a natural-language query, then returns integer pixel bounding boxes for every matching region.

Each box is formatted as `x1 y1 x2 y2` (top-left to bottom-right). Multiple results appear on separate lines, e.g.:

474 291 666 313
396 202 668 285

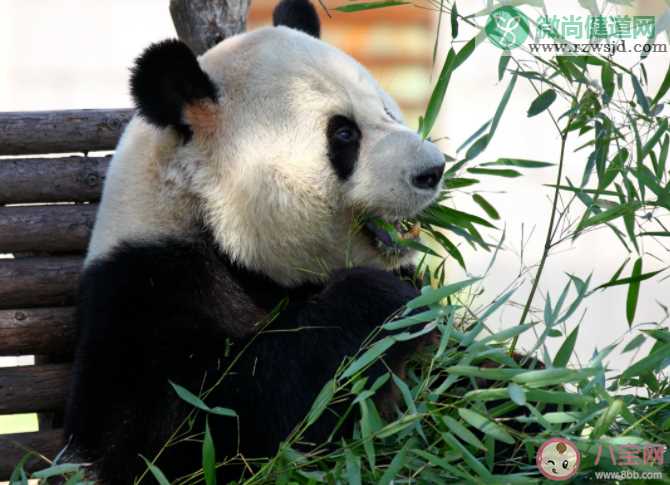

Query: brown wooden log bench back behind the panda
0 109 132 479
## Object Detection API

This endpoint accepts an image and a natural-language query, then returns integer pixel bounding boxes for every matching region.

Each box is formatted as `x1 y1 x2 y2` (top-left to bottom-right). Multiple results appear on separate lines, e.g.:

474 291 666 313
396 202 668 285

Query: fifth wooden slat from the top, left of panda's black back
0 307 76 356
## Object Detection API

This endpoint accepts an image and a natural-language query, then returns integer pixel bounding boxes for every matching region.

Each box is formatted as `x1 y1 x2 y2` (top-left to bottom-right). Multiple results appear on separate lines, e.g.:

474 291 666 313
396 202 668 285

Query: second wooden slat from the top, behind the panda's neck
0 153 111 204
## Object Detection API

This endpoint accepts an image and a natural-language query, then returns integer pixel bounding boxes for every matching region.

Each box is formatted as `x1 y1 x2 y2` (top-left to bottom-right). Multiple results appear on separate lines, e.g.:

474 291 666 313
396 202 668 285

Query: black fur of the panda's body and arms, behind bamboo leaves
66 233 426 485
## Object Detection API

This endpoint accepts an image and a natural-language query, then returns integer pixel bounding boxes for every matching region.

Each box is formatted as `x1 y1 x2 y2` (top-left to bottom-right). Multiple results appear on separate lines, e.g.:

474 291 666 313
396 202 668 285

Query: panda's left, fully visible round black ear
130 40 217 138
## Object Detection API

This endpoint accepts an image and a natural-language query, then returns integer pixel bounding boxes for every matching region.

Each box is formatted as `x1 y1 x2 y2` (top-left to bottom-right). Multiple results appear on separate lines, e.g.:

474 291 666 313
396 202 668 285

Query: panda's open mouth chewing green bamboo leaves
363 217 421 257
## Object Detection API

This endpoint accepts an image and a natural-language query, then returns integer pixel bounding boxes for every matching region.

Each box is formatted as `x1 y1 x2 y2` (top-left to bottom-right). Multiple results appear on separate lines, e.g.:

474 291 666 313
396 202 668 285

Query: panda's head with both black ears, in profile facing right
96 0 444 285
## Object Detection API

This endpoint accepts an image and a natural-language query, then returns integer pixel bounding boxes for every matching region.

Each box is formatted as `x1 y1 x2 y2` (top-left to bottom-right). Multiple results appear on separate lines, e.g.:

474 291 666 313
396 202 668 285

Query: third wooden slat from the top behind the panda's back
0 204 98 253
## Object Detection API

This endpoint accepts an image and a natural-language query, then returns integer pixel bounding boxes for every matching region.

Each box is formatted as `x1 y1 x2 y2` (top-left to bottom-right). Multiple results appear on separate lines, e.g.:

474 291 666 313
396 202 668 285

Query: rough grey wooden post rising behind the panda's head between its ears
170 0 250 56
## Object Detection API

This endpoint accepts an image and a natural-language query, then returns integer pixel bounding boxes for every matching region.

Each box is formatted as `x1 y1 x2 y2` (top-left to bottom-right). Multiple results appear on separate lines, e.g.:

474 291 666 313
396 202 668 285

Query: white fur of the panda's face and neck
87 27 441 285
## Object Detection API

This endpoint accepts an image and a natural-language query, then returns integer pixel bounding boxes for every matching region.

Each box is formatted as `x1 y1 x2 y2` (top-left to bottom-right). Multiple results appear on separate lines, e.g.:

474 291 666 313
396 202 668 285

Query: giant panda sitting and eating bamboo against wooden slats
65 0 444 484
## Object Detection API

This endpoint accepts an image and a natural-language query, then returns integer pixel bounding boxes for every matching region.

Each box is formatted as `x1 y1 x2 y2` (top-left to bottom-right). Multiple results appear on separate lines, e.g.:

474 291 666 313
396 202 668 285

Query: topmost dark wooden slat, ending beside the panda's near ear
0 109 133 155
